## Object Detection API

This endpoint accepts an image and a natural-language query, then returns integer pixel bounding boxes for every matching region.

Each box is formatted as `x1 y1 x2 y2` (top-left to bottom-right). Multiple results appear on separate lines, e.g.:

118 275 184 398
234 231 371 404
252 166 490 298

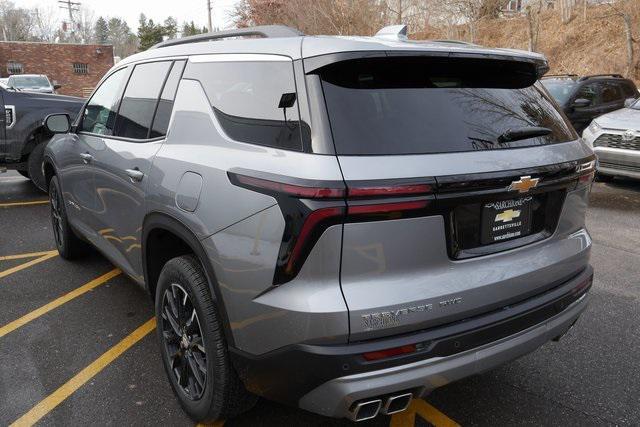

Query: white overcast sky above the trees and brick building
13 0 238 33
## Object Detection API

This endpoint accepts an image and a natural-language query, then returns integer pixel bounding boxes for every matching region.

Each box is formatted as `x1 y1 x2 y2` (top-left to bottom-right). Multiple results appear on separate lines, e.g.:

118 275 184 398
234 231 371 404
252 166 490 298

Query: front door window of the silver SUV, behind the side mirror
80 68 127 135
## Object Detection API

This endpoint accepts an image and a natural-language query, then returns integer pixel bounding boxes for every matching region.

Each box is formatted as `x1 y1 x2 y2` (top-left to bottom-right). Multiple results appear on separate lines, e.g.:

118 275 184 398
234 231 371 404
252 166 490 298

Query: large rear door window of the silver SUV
114 61 171 139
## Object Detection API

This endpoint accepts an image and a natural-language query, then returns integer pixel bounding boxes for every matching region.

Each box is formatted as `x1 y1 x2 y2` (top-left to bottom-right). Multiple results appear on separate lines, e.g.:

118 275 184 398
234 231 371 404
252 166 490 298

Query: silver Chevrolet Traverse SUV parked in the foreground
45 26 595 421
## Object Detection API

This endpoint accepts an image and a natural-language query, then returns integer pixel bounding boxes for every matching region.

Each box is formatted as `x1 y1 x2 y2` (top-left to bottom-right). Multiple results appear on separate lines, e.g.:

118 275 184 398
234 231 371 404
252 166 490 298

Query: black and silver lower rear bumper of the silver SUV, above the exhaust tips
232 266 593 417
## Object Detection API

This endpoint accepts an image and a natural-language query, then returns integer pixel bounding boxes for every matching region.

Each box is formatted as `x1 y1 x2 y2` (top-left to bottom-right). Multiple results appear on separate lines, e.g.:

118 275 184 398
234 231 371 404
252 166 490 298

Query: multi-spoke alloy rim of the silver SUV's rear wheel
161 283 207 400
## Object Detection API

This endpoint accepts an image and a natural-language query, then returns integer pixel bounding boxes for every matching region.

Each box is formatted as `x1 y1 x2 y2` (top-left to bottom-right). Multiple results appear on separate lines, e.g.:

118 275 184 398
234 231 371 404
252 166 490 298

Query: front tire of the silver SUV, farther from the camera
49 175 88 260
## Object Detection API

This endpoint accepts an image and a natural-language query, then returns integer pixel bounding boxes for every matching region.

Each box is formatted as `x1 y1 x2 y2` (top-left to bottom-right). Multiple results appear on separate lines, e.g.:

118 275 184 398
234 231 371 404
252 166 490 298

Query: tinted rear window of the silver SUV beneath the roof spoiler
319 57 577 155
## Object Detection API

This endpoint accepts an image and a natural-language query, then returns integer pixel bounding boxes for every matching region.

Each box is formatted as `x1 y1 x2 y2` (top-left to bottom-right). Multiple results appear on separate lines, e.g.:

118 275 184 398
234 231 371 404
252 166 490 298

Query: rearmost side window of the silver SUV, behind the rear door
185 60 308 151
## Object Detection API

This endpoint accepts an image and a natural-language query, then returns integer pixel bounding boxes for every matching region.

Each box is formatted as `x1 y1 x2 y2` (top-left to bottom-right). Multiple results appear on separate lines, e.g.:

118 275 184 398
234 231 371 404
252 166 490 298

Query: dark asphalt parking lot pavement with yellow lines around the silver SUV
0 172 640 427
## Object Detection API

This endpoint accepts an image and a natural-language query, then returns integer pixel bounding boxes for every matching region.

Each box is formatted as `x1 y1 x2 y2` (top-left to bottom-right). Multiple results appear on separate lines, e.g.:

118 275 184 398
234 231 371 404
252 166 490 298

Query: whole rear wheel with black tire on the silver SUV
155 255 257 423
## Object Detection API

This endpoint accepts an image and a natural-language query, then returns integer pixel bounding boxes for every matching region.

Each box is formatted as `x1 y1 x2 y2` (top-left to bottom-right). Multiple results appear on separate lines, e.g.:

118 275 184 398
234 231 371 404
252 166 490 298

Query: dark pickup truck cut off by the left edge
0 87 84 189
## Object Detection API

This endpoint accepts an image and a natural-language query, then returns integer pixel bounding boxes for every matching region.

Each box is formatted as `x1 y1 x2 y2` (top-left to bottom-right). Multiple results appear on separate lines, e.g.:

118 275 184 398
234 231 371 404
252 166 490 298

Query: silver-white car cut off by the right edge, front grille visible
582 100 640 181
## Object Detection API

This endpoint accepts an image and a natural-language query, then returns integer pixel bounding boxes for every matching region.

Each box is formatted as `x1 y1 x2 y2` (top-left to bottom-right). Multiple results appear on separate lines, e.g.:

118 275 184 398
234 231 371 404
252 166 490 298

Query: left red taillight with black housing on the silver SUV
228 172 432 285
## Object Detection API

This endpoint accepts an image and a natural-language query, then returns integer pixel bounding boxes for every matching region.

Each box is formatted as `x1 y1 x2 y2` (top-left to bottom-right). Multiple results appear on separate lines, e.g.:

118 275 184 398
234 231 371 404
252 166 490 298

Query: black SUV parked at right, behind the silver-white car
542 74 639 134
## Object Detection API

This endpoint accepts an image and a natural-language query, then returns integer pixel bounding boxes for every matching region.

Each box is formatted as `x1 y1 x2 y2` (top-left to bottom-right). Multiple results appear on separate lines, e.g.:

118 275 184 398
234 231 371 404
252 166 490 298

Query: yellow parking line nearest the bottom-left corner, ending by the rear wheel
11 317 156 427
